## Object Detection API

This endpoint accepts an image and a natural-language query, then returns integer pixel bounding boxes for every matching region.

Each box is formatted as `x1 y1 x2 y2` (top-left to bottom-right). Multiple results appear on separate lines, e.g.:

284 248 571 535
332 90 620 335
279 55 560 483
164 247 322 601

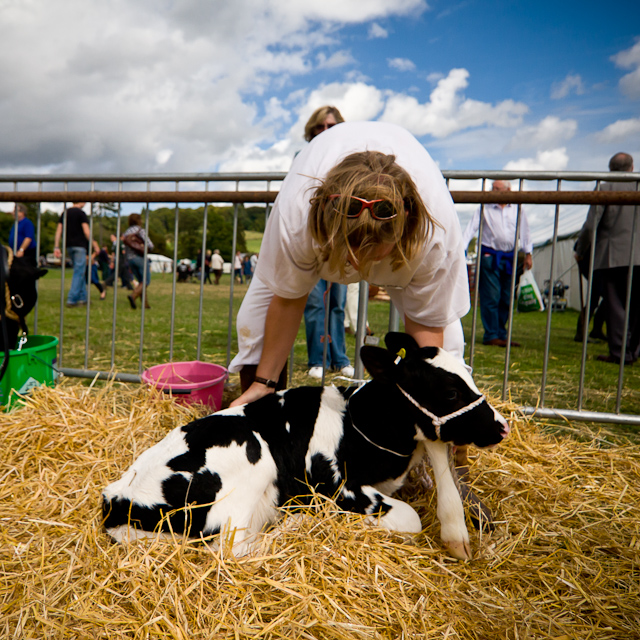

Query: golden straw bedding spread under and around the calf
0 381 640 640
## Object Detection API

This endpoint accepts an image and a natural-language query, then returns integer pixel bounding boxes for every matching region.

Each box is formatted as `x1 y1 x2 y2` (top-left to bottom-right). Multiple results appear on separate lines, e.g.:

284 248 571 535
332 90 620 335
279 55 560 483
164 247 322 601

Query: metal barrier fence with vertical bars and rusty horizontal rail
0 171 640 425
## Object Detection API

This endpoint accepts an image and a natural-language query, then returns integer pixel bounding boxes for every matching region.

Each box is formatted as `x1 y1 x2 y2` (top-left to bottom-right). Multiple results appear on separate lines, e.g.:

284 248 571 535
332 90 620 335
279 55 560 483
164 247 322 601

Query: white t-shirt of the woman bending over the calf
256 122 469 327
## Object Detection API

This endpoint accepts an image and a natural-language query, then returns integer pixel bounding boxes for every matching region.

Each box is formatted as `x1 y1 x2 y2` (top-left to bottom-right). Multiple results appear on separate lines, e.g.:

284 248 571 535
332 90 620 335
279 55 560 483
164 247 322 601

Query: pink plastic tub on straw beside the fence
142 360 229 411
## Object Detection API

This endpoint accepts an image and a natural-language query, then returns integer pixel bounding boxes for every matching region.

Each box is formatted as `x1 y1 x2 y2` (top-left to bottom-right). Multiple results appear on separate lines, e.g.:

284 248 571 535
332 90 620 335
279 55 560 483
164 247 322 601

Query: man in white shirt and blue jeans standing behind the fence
462 180 533 347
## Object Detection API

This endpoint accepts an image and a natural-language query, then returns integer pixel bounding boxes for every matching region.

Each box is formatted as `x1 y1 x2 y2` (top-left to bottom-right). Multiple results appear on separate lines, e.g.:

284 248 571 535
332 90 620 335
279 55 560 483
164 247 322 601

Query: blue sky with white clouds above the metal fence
0 0 640 238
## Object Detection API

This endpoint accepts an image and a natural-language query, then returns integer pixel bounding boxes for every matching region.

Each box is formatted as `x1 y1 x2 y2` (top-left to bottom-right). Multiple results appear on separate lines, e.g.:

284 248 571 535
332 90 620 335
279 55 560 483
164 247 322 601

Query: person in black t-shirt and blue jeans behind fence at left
53 202 91 307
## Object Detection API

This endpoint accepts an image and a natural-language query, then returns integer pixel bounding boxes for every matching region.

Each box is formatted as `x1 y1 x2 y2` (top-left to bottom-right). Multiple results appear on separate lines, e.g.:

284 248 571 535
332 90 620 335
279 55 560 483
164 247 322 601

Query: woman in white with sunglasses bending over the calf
229 122 469 406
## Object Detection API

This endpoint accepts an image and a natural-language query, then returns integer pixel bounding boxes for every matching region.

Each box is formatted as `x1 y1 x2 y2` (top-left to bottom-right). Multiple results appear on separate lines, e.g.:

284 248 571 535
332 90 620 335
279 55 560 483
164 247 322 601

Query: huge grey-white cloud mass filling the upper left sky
0 0 427 173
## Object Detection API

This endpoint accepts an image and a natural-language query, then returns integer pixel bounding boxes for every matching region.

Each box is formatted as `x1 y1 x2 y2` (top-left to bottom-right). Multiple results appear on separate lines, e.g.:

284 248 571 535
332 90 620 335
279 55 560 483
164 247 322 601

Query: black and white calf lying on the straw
103 333 509 559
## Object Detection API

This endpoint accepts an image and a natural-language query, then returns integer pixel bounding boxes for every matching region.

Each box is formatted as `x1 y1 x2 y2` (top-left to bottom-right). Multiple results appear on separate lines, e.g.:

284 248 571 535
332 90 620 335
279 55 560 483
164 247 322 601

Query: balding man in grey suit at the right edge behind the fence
575 153 640 365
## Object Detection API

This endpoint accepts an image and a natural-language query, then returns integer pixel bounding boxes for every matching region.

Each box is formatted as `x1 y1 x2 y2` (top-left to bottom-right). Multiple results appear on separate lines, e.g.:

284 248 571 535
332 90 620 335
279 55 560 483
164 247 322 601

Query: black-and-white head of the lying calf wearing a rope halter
360 332 509 447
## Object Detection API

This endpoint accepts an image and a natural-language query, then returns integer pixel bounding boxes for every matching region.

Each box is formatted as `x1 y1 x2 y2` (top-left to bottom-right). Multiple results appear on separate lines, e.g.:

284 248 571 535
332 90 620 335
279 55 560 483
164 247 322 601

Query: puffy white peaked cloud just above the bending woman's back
380 69 528 138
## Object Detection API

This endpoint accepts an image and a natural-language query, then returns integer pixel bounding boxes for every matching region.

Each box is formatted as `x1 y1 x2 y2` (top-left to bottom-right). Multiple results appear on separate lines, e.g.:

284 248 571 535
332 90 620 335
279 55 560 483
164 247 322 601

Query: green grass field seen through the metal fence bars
25 270 640 436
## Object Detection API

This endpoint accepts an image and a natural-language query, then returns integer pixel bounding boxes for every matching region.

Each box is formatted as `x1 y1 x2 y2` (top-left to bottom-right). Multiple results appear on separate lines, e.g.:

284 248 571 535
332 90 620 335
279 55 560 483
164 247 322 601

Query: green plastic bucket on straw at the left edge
0 336 58 411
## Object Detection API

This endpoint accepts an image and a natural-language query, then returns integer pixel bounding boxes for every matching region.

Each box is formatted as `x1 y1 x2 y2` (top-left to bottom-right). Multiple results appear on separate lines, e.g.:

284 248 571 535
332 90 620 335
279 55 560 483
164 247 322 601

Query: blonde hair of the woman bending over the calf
309 151 437 277
